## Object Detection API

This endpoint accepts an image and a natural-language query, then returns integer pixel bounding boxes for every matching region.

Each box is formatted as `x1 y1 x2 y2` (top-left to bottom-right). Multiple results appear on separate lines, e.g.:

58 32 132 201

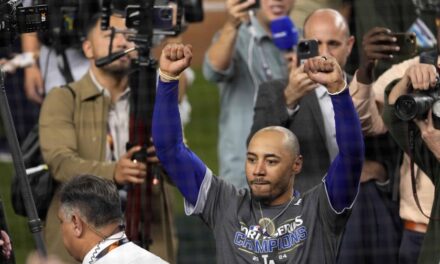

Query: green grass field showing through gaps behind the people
0 67 218 263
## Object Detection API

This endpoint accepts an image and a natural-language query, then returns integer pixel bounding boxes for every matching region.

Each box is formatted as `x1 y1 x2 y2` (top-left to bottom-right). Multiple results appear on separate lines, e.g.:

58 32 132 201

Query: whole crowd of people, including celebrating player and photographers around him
0 0 440 264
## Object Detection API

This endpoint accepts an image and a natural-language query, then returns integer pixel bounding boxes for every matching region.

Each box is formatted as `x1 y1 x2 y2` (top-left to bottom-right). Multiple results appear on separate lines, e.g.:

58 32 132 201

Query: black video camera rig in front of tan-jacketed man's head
95 0 203 67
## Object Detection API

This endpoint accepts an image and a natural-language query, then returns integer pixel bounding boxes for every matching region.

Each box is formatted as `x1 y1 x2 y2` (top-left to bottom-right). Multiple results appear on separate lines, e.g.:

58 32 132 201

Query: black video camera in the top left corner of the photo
0 0 49 47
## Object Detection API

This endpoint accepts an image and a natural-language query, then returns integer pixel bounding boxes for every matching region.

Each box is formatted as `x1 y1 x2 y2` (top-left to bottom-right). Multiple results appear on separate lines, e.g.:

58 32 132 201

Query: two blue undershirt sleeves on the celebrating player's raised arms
152 80 364 212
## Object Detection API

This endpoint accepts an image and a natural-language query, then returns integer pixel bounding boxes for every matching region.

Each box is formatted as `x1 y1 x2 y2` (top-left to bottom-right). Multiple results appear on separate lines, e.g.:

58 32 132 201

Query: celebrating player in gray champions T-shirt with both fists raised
152 44 364 264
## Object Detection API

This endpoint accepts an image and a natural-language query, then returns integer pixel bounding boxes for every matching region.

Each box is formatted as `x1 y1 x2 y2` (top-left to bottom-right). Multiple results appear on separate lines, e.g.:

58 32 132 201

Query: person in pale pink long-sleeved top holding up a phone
350 24 440 264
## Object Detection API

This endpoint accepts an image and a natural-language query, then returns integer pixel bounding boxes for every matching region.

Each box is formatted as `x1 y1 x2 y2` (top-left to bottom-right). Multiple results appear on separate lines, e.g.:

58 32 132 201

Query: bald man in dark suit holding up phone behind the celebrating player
250 9 354 192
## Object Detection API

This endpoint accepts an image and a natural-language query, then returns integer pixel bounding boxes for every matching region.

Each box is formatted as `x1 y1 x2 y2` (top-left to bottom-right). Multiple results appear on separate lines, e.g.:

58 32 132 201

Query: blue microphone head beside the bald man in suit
270 16 299 52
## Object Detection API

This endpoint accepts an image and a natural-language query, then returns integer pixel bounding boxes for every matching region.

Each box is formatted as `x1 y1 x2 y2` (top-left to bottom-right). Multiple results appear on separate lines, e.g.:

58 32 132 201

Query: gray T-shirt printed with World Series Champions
185 169 350 264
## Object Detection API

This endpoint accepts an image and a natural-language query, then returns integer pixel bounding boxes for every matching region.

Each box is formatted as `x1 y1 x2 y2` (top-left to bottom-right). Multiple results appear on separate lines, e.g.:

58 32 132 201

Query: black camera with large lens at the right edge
394 79 440 129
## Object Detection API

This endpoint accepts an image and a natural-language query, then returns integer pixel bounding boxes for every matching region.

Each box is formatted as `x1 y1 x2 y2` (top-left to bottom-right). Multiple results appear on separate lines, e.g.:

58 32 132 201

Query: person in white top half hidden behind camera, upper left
21 0 100 104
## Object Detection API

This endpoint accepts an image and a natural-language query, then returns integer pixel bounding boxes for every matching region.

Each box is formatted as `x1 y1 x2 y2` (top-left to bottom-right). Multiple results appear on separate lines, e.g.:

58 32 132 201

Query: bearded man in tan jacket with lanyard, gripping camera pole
39 13 175 263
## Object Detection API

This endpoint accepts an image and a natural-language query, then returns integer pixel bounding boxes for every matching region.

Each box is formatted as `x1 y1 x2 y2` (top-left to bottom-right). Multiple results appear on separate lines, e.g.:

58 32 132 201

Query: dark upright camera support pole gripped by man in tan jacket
95 0 183 249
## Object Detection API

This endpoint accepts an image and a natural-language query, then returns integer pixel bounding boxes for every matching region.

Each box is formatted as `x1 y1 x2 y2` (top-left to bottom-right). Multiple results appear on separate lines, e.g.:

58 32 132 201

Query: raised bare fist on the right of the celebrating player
304 56 346 94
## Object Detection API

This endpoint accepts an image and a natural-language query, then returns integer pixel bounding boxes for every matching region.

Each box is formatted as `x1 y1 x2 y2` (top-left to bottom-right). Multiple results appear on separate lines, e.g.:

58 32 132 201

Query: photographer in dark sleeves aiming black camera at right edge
383 63 440 263
